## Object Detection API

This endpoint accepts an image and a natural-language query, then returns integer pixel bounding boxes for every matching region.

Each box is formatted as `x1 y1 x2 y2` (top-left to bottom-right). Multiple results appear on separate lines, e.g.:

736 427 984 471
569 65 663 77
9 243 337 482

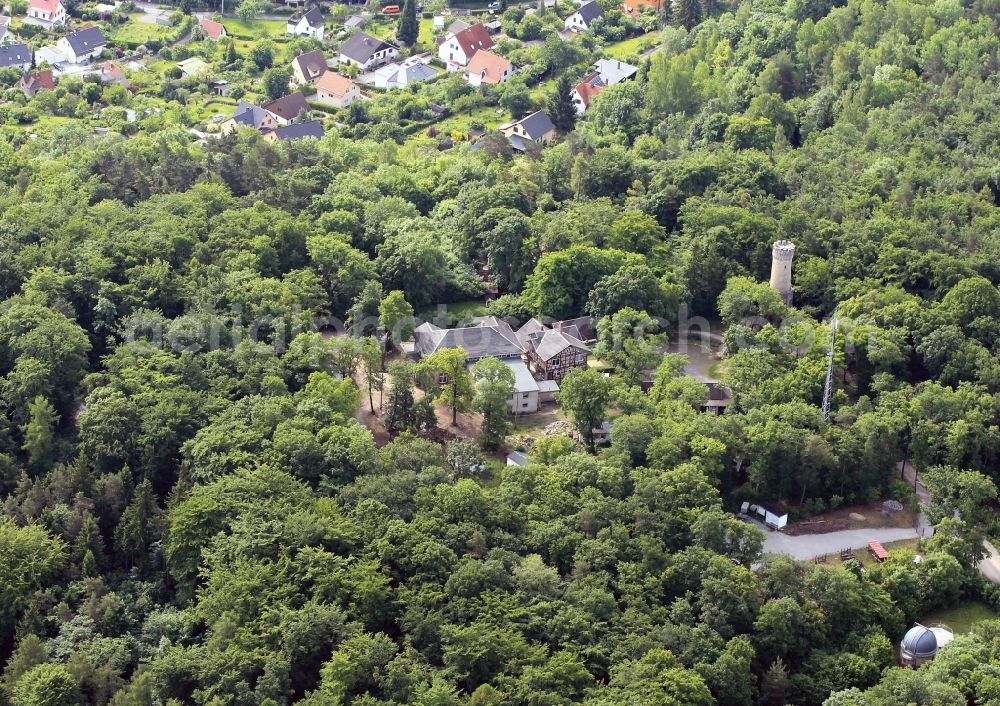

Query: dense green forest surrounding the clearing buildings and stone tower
0 0 1000 706
